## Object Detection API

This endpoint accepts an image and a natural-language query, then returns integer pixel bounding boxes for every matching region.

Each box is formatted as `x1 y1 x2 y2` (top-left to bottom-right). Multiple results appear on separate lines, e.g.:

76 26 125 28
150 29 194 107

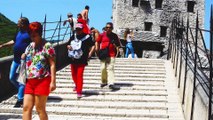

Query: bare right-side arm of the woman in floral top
48 57 56 91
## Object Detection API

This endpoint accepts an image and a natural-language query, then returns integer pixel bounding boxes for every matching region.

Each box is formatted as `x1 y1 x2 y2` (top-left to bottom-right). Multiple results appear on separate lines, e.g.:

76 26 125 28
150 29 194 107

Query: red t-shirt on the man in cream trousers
96 32 120 57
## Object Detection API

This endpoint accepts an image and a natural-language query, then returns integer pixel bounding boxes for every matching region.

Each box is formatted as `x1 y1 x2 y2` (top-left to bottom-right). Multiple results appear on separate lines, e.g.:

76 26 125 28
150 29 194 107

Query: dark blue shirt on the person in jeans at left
13 31 31 63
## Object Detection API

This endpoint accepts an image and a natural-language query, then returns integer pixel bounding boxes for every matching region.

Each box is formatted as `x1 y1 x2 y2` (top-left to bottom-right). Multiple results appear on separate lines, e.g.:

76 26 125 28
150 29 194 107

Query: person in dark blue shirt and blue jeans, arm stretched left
0 17 31 107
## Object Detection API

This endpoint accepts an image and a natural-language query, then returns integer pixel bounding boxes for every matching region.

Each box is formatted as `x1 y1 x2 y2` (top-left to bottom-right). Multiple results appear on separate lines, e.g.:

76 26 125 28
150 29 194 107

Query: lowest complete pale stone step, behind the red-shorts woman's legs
0 105 169 118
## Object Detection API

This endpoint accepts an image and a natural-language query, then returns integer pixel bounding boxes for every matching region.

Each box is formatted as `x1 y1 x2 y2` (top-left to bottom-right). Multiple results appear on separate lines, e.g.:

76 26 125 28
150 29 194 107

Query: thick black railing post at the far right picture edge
208 6 213 120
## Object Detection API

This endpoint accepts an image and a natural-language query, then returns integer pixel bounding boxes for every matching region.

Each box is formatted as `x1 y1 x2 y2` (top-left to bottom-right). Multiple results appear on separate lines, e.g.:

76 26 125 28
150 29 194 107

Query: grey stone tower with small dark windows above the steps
112 0 205 58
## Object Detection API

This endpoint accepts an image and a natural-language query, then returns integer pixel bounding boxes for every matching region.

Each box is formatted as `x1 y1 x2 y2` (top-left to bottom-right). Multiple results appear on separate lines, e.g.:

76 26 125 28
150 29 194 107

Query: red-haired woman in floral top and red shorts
22 22 56 120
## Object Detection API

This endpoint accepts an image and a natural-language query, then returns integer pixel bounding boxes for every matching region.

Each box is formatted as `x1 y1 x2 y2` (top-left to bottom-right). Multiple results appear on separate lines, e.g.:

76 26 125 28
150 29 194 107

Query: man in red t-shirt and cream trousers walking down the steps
95 22 120 90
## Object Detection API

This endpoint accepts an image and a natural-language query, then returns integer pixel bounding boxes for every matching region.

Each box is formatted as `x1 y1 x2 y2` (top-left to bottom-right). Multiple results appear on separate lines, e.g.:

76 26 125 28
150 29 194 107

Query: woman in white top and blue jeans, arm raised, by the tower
124 28 135 58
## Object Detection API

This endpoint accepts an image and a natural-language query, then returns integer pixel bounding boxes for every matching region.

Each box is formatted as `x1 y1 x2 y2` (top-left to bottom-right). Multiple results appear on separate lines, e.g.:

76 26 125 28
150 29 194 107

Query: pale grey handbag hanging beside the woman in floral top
16 60 27 85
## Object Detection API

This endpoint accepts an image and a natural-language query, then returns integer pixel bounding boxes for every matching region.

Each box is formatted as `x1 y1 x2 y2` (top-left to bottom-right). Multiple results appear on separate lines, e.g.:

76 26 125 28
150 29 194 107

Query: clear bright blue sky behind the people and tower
0 0 213 47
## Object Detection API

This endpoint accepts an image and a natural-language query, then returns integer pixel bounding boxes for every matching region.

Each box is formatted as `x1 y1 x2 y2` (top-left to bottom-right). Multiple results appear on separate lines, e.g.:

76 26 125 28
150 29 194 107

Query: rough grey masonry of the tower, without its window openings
112 0 205 56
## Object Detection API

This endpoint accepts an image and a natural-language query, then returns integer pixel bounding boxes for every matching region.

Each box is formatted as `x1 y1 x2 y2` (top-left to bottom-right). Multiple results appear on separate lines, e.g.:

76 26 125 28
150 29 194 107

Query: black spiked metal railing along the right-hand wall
167 8 213 120
